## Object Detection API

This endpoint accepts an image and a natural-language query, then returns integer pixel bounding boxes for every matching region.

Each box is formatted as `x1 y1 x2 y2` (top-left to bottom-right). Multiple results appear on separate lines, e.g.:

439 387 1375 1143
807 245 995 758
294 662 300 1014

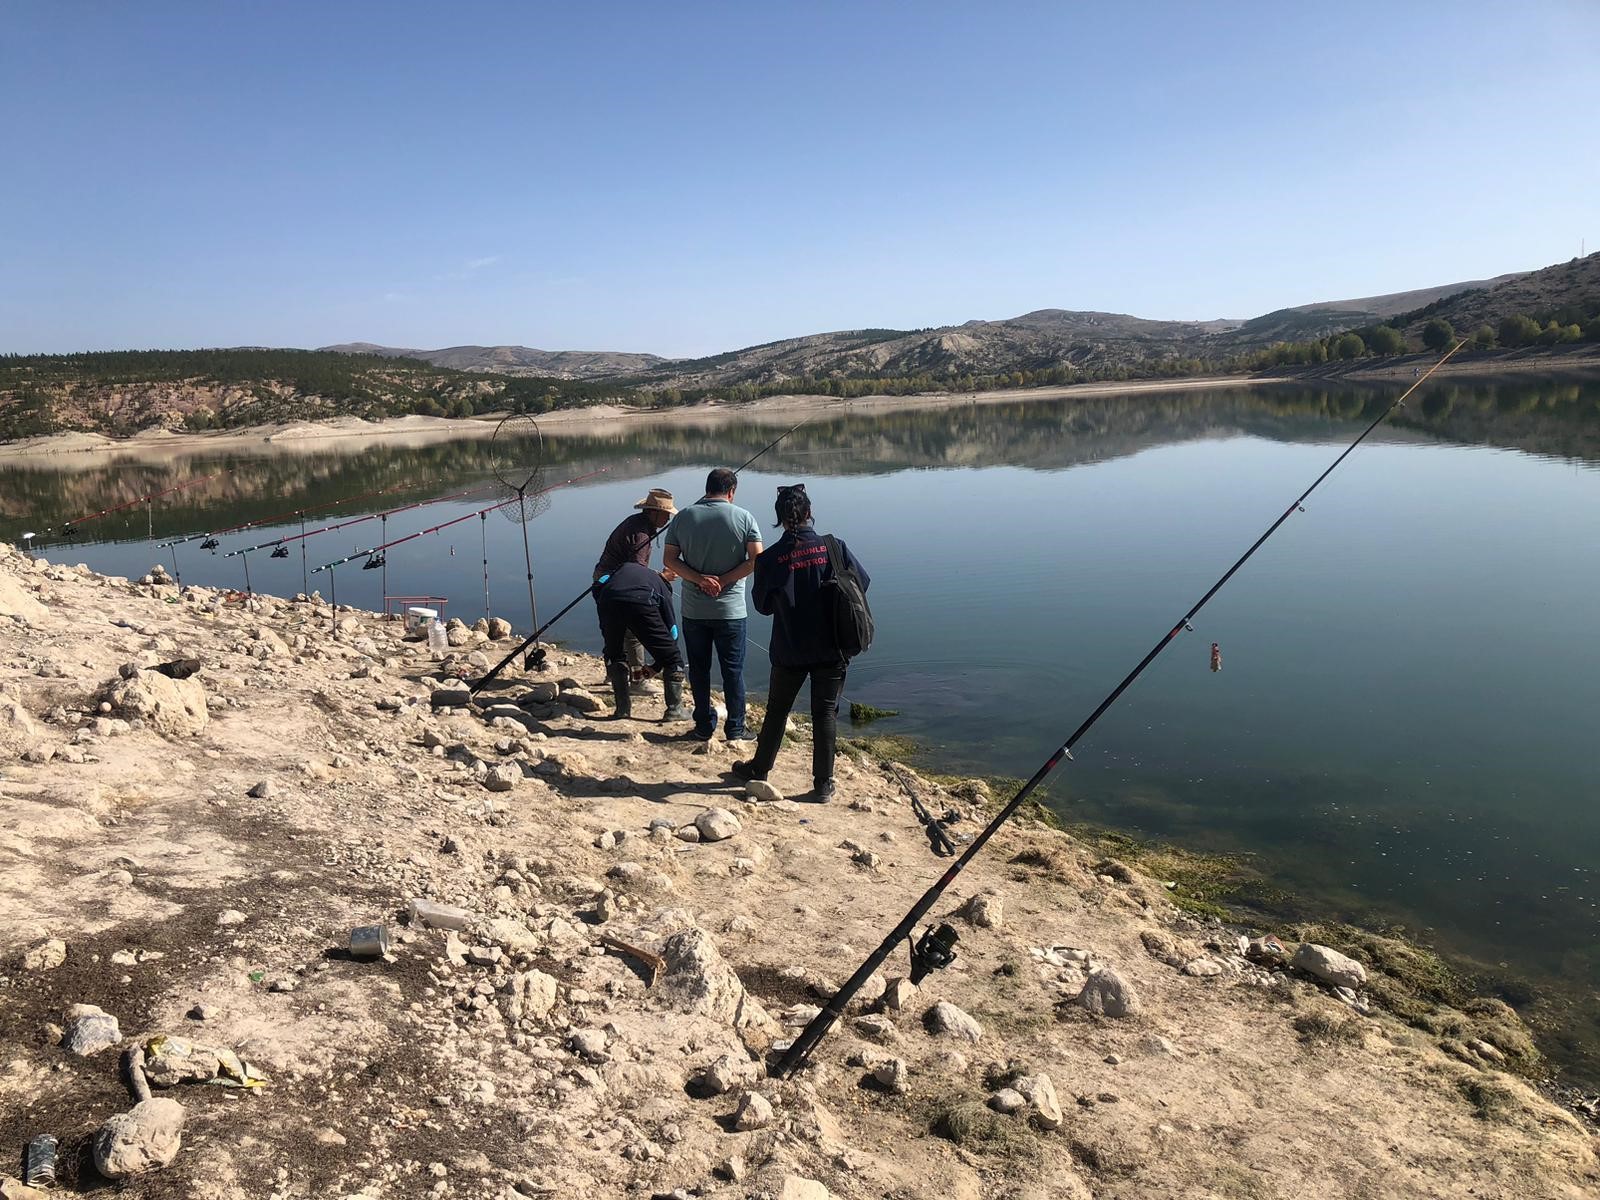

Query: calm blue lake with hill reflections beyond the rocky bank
0 379 1600 1083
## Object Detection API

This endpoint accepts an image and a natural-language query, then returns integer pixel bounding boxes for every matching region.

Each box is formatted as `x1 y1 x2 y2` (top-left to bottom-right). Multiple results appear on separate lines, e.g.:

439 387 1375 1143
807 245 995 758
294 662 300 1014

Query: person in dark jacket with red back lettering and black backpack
733 483 870 803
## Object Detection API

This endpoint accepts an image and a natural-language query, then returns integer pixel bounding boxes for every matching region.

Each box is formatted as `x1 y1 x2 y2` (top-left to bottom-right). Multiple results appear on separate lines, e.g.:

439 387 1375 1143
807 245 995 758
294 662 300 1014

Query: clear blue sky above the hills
0 0 1600 355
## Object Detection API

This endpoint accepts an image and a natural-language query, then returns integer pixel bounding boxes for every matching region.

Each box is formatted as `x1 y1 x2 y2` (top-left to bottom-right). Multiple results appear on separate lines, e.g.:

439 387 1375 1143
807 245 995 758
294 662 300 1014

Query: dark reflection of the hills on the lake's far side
0 379 1600 536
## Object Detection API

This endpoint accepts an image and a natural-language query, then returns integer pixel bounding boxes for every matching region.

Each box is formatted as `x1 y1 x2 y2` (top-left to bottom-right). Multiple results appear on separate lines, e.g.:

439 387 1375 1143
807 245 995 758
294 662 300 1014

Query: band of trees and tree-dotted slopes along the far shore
0 301 1600 437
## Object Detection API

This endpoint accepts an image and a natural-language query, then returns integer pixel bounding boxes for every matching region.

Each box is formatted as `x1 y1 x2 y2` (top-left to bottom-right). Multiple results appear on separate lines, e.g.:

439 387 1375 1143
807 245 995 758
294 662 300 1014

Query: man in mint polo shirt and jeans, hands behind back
661 467 762 741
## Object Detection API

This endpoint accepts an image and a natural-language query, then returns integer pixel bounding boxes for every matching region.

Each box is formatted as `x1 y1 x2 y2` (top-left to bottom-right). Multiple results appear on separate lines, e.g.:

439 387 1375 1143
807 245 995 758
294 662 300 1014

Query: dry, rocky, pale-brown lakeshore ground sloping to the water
0 547 1600 1200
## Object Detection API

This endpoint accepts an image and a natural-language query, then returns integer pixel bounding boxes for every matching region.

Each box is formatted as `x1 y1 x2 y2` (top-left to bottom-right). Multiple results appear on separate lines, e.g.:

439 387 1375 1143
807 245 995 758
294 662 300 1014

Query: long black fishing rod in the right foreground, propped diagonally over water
773 341 1466 1078
